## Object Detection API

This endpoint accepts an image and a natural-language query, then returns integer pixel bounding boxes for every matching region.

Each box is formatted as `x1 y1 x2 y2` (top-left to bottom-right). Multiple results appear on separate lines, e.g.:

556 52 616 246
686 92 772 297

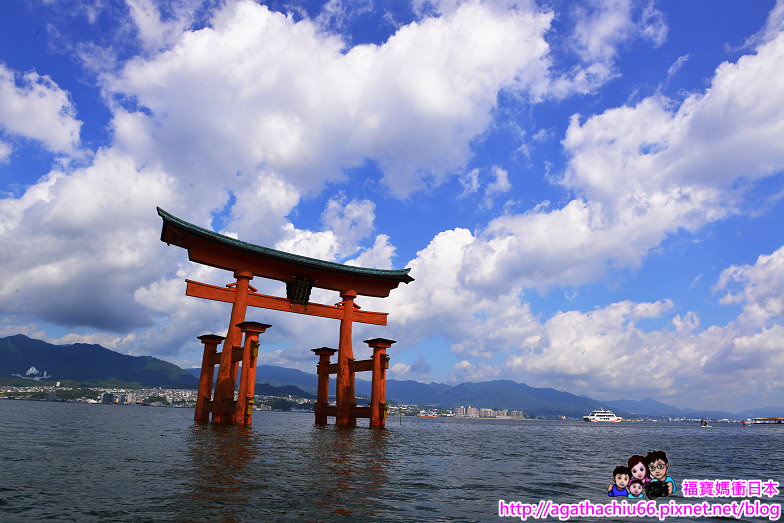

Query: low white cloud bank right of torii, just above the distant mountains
388 239 784 410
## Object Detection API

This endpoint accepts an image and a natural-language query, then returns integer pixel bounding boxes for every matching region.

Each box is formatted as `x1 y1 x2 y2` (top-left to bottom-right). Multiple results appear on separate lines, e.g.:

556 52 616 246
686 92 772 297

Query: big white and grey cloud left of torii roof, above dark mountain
0 152 176 332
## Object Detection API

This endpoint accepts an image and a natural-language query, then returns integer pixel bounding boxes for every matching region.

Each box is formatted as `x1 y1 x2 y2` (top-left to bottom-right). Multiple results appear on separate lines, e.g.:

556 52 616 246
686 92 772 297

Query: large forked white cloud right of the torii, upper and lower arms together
364 22 784 409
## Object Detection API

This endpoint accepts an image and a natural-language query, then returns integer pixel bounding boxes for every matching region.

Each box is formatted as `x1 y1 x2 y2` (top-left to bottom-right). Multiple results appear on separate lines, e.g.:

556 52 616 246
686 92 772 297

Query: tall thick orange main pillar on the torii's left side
212 271 253 423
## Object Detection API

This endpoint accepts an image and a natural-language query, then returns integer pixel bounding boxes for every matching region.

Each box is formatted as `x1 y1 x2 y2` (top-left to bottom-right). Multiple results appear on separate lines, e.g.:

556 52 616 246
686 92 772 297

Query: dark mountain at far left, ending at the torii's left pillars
0 334 198 387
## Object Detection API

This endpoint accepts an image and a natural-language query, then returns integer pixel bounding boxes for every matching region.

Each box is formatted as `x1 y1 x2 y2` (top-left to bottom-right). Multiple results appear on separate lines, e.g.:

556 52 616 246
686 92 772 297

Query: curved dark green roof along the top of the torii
157 207 414 283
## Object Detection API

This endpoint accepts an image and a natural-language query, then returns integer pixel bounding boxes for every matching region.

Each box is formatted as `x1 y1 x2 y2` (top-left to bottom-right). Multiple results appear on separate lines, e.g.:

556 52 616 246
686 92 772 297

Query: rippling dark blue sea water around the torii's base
0 400 784 522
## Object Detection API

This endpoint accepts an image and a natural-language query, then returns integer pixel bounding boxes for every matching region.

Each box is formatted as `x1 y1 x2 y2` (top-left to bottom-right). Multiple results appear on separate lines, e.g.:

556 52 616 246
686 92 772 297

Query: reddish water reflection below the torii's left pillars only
178 422 260 521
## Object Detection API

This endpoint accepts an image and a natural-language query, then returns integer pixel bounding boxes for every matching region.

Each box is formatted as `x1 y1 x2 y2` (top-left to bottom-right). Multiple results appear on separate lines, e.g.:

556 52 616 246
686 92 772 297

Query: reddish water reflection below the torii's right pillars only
306 425 390 520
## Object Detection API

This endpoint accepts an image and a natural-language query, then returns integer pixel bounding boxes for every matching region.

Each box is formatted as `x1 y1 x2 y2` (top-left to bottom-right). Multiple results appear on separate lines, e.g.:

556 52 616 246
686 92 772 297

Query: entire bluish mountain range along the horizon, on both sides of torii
0 334 784 419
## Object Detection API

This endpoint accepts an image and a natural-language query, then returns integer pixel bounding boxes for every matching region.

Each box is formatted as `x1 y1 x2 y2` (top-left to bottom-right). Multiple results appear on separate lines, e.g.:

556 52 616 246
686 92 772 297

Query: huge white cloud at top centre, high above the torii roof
106 1 551 196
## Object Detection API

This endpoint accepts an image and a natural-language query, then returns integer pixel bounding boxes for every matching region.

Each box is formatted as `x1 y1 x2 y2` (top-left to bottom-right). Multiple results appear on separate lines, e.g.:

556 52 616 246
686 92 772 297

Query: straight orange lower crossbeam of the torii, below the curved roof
185 280 387 325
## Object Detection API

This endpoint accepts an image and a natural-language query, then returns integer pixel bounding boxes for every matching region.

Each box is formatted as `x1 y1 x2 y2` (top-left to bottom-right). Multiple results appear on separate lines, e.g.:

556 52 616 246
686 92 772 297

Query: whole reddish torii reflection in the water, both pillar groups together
174 414 391 521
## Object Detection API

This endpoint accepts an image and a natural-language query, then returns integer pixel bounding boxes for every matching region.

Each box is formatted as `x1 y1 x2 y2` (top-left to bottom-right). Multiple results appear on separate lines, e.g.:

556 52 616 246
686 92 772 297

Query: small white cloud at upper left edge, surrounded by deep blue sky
0 63 82 156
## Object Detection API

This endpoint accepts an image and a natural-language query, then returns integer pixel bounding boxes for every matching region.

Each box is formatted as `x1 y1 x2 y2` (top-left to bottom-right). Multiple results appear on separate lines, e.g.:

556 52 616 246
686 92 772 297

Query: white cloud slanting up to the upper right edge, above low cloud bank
462 28 784 291
